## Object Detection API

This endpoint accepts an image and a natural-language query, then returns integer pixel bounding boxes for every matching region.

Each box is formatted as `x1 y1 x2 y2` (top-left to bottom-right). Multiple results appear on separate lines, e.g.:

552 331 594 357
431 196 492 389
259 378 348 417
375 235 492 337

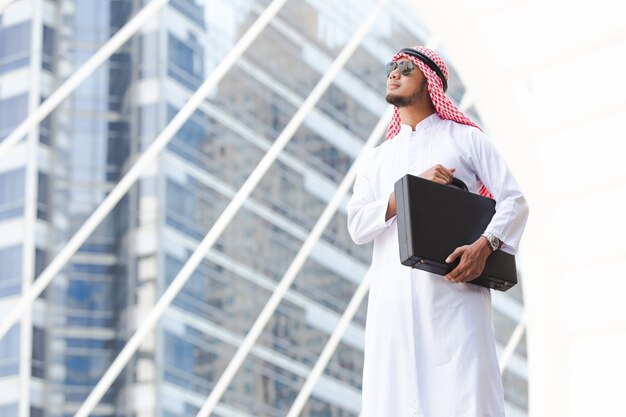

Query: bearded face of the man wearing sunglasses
385 58 430 107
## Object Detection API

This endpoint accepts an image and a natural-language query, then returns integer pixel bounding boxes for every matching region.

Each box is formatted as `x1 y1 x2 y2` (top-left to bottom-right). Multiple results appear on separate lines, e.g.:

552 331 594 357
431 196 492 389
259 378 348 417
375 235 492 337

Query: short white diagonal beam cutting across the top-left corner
0 0 168 158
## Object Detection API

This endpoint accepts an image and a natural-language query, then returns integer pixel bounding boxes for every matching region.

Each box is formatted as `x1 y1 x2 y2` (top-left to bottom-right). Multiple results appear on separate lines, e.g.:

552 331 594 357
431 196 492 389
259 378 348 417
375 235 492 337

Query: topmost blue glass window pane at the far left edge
0 21 30 74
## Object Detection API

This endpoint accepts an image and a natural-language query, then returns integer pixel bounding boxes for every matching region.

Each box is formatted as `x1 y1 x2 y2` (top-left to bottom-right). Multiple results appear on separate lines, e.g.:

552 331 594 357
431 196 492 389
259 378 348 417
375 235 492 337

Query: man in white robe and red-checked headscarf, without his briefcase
348 47 528 417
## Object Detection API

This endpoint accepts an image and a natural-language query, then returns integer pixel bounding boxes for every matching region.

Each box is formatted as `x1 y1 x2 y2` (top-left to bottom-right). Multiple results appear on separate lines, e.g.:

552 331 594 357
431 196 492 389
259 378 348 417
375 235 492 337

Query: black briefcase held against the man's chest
394 174 517 291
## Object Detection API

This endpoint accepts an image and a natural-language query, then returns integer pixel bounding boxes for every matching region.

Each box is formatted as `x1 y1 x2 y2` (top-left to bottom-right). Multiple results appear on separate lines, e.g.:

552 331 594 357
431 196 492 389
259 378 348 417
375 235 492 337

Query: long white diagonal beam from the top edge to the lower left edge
0 0 287 340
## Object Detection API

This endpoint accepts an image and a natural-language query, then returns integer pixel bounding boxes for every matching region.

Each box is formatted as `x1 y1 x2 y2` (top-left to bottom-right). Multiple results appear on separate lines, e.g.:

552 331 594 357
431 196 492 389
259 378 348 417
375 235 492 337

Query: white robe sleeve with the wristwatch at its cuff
469 129 528 255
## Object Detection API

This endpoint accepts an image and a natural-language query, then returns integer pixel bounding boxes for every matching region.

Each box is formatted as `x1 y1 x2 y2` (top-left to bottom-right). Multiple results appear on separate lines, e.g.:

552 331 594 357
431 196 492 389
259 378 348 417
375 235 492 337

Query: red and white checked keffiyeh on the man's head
386 46 493 198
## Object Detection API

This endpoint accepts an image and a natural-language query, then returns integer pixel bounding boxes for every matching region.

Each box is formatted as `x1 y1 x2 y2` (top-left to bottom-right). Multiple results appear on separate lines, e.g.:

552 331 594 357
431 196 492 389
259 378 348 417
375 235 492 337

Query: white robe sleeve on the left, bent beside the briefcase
347 150 395 245
